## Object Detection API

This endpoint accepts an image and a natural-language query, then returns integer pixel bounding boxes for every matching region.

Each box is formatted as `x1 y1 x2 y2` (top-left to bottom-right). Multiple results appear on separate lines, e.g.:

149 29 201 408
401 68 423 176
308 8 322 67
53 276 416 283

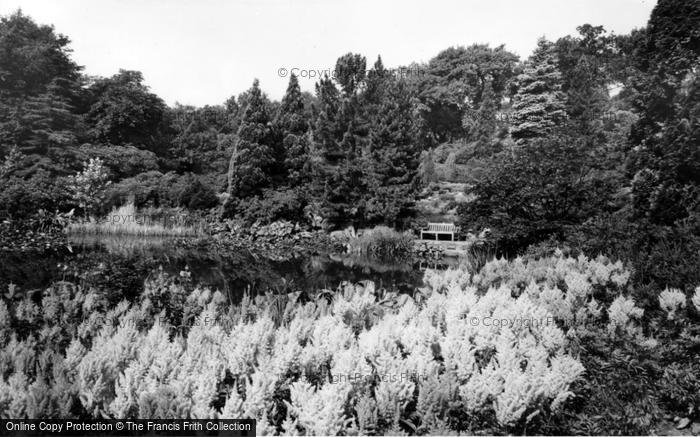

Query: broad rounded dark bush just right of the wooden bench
459 134 614 253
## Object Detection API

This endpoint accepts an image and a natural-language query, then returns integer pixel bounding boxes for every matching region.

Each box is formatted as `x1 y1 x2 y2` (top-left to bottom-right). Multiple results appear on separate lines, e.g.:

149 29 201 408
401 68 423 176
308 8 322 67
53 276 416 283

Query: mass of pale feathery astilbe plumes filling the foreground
0 256 668 435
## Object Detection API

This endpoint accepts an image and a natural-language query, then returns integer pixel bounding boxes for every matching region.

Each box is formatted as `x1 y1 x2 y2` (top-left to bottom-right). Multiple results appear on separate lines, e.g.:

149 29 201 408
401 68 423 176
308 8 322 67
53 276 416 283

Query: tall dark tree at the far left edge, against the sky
0 11 83 161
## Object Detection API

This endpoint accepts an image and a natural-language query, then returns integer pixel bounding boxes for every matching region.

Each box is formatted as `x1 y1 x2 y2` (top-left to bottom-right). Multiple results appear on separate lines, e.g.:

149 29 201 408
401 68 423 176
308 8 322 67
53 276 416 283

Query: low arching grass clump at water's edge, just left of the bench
348 226 413 258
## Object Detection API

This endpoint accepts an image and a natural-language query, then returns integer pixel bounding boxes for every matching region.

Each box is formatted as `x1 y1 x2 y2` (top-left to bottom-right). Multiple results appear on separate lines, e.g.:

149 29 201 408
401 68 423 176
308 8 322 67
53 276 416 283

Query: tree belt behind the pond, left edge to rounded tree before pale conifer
0 11 528 227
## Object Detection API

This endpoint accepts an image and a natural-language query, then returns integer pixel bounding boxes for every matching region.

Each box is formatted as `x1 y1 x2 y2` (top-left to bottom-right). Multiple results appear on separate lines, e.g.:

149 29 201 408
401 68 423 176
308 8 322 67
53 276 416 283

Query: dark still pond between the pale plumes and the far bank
0 233 456 301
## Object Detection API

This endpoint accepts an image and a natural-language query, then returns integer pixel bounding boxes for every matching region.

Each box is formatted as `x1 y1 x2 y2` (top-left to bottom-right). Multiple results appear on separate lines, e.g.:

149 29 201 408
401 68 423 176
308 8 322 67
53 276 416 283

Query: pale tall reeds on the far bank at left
67 202 204 237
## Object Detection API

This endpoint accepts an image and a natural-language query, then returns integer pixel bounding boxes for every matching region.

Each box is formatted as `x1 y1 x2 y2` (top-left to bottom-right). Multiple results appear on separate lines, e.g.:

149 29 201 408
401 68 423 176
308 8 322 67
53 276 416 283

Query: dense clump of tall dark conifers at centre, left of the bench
309 54 421 226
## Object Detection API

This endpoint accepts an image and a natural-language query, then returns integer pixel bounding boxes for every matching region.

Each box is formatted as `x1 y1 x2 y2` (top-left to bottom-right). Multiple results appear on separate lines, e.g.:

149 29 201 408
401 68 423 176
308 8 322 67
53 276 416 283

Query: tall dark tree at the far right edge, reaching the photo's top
629 0 700 225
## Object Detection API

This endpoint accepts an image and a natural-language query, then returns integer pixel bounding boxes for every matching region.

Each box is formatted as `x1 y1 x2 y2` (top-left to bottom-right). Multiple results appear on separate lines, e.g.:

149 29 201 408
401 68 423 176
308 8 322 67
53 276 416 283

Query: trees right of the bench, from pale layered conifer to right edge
460 0 700 287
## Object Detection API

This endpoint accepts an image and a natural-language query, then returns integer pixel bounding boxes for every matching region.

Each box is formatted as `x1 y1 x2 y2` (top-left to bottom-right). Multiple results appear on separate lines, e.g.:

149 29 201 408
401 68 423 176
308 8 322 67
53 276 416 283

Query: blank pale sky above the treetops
0 0 656 106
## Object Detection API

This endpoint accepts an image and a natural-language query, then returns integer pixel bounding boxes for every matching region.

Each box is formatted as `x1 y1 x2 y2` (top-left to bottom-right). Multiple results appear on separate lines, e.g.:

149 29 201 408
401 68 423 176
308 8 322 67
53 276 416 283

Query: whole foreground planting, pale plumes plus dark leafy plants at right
0 255 700 435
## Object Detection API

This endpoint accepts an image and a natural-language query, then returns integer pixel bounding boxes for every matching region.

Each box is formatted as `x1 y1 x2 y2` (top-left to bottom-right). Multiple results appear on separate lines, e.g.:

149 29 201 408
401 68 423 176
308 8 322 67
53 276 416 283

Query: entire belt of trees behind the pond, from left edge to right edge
0 0 700 290
